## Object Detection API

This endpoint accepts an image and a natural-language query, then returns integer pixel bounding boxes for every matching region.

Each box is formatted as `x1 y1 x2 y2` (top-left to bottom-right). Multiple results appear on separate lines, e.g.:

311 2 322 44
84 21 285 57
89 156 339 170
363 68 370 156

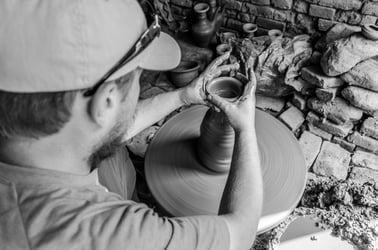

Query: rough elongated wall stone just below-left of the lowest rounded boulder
307 97 363 124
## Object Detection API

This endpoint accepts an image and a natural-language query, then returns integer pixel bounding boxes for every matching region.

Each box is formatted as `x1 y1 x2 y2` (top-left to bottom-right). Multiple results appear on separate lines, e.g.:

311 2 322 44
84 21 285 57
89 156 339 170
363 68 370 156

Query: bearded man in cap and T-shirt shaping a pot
0 0 262 250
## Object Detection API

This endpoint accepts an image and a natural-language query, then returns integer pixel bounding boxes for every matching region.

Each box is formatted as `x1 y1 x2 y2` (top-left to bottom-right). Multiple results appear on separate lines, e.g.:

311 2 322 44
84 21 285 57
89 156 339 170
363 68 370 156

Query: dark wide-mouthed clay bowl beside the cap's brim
169 61 200 88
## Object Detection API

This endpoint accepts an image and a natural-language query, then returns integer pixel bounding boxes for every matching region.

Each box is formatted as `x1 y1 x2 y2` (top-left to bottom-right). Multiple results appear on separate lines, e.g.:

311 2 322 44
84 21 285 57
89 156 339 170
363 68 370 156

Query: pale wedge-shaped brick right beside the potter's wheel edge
299 131 323 169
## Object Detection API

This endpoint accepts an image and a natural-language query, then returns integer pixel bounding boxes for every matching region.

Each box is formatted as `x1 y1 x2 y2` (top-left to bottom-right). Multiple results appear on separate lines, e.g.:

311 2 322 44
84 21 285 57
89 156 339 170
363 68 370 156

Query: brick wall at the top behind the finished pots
170 0 378 34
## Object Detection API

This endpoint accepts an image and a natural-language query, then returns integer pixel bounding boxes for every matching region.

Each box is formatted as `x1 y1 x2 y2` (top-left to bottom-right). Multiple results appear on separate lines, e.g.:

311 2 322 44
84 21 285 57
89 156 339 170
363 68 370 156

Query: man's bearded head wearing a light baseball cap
0 0 180 170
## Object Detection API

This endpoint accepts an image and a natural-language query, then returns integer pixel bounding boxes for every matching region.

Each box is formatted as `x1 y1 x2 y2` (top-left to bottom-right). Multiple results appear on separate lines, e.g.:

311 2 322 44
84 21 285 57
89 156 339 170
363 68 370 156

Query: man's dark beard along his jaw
88 118 125 172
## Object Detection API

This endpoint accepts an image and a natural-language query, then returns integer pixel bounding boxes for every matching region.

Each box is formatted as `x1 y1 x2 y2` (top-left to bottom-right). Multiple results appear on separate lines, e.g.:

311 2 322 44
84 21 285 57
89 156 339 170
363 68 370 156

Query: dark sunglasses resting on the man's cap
84 14 161 97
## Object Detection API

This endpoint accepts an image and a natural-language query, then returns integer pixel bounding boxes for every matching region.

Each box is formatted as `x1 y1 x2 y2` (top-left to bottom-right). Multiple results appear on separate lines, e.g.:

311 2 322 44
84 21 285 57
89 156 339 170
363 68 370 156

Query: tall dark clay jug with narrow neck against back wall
191 3 215 48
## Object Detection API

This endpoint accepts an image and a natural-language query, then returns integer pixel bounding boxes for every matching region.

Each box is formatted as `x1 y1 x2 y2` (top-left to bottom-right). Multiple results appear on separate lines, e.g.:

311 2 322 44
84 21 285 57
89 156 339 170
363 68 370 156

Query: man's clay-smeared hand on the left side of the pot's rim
180 51 239 105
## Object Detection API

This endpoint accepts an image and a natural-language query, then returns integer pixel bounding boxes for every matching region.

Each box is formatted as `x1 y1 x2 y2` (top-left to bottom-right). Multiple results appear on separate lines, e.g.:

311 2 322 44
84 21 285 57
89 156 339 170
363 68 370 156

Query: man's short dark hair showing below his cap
0 72 134 141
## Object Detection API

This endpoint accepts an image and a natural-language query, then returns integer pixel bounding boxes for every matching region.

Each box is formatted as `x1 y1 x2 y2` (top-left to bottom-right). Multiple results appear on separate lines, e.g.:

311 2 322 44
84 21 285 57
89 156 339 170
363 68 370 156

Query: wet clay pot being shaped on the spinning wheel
196 77 243 173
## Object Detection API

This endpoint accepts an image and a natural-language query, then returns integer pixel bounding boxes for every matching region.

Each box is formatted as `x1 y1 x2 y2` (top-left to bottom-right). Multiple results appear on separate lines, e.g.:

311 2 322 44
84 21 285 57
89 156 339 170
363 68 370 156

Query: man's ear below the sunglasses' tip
88 82 120 127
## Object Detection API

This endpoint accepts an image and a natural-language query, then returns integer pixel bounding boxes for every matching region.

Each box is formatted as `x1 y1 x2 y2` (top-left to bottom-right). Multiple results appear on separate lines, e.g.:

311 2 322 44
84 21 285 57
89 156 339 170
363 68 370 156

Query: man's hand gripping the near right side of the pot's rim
207 66 256 132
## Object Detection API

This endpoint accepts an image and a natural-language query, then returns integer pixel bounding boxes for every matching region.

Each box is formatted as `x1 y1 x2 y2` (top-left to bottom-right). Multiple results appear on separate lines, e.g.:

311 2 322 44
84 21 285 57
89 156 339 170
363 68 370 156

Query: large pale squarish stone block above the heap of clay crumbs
312 141 350 180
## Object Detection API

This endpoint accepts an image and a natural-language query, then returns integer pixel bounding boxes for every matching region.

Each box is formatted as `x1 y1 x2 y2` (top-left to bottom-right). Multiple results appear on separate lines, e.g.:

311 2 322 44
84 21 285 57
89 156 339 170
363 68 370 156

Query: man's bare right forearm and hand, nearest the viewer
209 69 263 250
